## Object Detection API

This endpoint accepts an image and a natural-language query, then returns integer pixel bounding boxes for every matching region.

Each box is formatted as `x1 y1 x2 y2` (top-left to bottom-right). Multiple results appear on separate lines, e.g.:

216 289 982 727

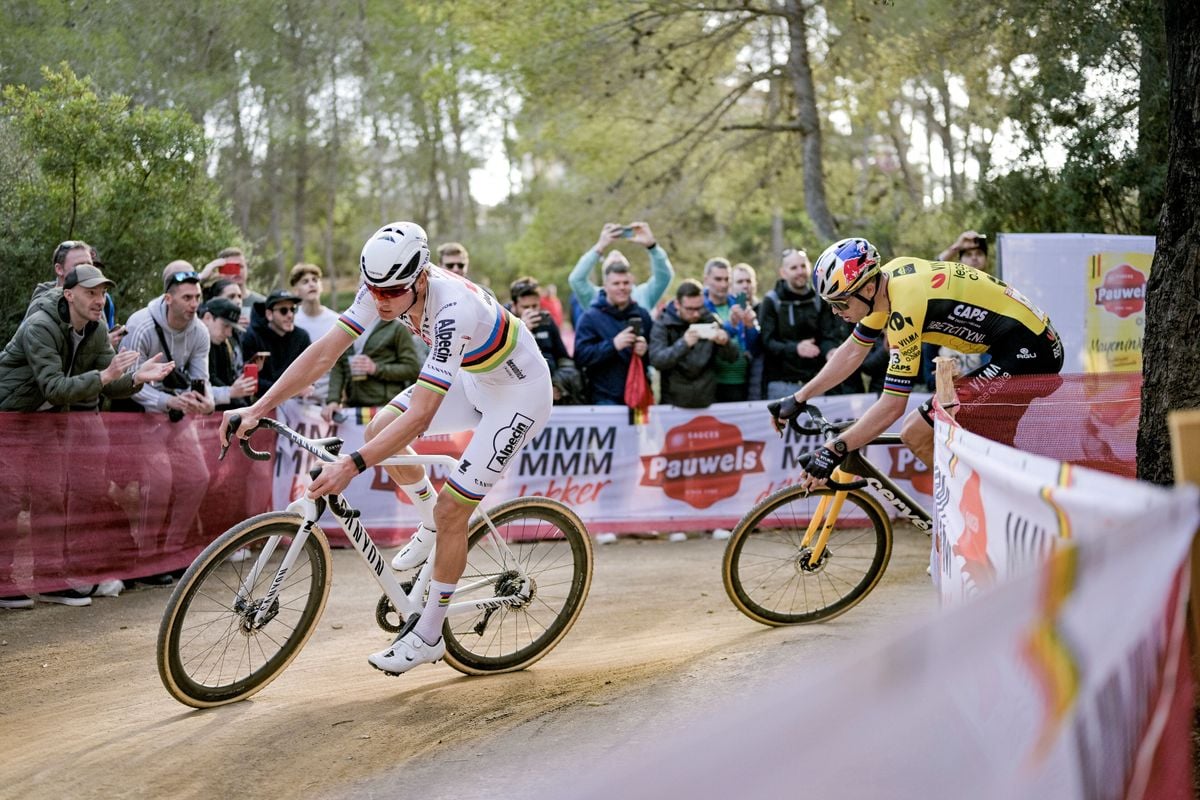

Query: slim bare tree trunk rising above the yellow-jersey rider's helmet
784 0 838 242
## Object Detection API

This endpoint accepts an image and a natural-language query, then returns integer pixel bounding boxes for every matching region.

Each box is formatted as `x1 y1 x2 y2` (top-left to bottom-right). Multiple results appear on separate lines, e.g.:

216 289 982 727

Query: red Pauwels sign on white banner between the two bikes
641 415 763 509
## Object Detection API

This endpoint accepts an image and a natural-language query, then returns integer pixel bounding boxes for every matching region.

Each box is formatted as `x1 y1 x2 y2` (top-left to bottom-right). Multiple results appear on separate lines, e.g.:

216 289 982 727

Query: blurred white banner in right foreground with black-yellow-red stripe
561 423 1200 800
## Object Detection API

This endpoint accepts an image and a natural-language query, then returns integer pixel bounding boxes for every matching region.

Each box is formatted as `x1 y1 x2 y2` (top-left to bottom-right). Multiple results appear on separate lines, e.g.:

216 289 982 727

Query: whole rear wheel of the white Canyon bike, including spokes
442 498 592 675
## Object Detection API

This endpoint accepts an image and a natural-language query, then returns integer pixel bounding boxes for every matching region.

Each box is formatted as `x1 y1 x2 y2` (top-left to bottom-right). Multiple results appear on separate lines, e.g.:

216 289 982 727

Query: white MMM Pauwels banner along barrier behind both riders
275 395 932 545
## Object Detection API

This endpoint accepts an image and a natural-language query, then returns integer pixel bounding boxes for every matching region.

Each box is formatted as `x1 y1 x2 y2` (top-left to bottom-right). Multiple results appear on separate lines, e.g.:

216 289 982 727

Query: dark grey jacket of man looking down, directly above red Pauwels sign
649 300 740 408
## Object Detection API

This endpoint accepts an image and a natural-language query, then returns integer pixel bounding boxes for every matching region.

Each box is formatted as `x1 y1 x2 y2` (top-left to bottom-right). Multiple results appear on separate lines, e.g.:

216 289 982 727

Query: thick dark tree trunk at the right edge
1138 0 1200 483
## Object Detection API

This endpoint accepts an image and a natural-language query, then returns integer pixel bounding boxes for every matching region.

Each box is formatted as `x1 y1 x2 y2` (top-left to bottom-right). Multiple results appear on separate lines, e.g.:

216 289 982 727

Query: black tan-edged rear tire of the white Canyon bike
442 497 593 675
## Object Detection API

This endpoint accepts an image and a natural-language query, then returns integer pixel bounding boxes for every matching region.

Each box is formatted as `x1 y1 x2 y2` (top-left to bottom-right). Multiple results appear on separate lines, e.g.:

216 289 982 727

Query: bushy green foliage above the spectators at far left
0 65 236 341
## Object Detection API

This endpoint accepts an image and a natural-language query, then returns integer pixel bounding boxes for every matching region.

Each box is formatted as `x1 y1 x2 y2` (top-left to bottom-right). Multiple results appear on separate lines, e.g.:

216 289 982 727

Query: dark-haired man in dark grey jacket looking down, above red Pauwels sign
650 278 739 408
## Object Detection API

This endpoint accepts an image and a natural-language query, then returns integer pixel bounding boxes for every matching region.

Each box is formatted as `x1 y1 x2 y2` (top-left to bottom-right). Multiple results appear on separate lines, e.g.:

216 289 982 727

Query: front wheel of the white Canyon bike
158 512 330 708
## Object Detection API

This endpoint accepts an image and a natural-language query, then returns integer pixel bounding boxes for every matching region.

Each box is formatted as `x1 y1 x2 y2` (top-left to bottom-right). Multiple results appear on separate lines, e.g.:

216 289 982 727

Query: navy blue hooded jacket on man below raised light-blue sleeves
575 295 654 405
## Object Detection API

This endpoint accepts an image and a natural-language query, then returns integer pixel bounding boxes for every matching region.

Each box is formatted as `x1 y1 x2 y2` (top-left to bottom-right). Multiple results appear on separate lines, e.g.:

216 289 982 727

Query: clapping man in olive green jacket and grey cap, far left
0 266 174 411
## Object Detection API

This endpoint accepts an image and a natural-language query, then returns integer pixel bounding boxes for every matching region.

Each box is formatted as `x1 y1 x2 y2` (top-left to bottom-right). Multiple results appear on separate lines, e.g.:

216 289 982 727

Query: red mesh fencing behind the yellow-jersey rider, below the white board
955 373 1141 477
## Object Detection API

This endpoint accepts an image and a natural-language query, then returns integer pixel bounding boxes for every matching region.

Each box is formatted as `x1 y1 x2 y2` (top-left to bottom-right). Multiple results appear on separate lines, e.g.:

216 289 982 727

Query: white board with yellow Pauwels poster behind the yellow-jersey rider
1000 234 1154 373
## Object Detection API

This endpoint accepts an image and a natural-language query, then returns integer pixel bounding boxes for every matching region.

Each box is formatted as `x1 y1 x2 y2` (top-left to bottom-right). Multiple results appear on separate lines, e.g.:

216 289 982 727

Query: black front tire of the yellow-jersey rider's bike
721 486 892 626
